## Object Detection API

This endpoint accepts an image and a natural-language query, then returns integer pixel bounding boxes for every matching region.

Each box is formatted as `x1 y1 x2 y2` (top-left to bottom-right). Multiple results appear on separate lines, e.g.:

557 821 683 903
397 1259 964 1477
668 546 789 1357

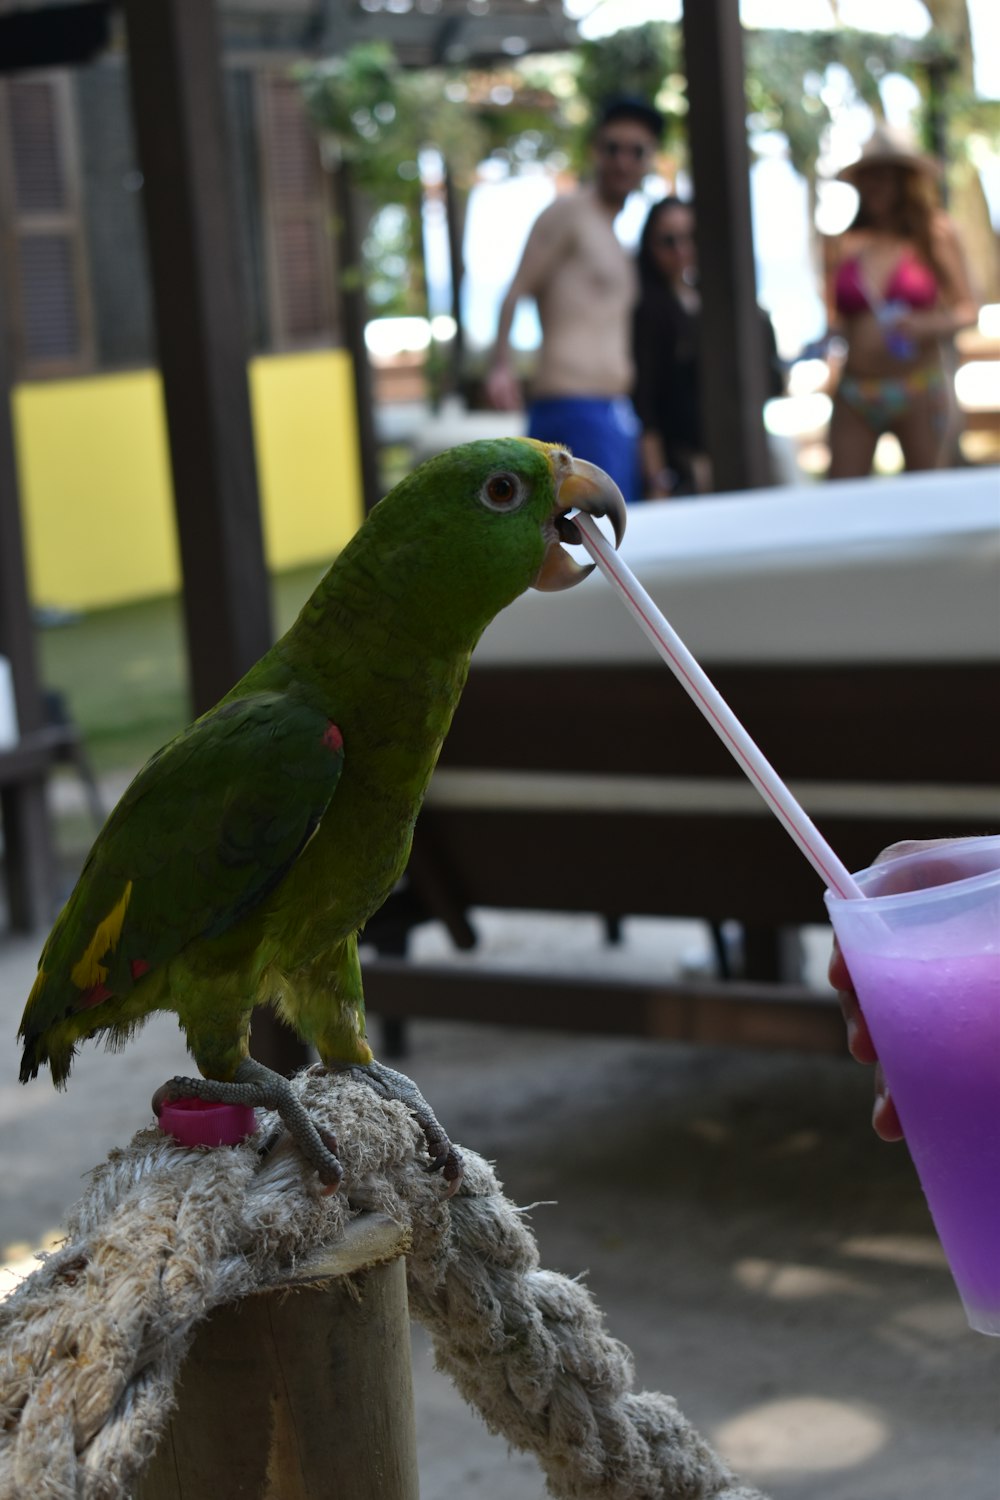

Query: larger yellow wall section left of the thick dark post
13 371 180 609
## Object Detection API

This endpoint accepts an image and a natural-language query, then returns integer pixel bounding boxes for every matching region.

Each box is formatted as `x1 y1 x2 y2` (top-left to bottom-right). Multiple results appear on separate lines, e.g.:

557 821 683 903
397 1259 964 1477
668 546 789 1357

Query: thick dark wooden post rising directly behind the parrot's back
124 0 273 713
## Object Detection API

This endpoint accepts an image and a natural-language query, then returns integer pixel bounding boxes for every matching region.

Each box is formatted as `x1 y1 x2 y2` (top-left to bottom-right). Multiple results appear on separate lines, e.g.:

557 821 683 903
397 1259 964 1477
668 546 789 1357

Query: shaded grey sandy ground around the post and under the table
0 917 1000 1500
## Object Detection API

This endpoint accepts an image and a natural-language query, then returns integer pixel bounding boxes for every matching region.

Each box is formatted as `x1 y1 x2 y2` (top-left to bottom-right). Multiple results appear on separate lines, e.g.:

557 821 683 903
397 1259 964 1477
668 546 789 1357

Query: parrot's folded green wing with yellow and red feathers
21 693 343 1073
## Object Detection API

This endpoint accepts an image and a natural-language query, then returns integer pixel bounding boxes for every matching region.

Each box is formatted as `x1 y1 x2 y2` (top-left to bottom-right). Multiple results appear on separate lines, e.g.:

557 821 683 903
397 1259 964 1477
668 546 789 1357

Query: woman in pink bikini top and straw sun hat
828 126 978 479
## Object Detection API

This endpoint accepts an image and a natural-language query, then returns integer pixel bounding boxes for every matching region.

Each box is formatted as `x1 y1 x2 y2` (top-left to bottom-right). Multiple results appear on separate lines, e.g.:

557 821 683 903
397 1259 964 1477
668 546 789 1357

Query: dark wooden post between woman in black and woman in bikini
684 0 771 491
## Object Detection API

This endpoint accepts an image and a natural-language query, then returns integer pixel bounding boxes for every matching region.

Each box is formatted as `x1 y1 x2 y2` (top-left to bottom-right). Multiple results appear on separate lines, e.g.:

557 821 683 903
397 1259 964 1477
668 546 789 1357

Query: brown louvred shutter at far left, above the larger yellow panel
0 75 91 375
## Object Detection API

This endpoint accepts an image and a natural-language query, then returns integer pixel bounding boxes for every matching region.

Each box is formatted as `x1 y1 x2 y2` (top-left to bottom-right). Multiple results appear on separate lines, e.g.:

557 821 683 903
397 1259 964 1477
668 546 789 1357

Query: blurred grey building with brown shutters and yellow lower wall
0 0 570 606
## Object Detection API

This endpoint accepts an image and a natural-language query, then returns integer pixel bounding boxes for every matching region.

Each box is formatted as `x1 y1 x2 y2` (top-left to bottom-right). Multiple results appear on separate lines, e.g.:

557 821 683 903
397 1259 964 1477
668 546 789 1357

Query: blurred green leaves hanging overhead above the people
295 21 982 201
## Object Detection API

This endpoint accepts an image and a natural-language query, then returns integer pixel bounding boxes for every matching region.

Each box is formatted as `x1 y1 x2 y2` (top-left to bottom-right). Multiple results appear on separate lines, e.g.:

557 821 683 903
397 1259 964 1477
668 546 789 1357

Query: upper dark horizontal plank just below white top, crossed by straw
441 656 1000 786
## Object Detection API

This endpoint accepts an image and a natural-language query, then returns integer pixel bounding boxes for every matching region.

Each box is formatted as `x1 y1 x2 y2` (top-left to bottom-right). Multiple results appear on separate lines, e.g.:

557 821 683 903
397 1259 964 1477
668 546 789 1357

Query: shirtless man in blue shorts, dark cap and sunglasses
486 99 663 500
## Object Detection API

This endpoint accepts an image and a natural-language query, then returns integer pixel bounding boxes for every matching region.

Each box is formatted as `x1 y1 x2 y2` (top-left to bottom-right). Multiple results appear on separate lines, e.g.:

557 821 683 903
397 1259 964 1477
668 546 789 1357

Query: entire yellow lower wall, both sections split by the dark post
13 350 361 609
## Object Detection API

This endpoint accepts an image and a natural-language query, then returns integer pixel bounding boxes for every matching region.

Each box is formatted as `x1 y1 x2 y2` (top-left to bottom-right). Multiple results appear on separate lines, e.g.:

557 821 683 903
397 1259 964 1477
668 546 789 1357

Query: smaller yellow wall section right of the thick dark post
250 350 361 572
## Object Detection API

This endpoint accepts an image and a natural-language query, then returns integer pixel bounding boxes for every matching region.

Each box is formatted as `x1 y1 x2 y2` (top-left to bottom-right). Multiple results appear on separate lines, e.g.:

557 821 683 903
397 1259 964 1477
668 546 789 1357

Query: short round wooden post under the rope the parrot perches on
136 1214 418 1500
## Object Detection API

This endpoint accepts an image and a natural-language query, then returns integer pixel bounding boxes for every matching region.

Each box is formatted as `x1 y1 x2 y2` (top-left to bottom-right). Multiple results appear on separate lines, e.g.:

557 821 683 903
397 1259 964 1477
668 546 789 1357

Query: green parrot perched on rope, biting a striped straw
18 438 625 1190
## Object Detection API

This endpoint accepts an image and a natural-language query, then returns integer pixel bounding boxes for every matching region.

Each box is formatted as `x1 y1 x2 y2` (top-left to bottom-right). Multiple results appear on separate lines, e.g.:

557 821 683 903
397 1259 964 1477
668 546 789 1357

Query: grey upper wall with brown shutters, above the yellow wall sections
0 54 337 380
